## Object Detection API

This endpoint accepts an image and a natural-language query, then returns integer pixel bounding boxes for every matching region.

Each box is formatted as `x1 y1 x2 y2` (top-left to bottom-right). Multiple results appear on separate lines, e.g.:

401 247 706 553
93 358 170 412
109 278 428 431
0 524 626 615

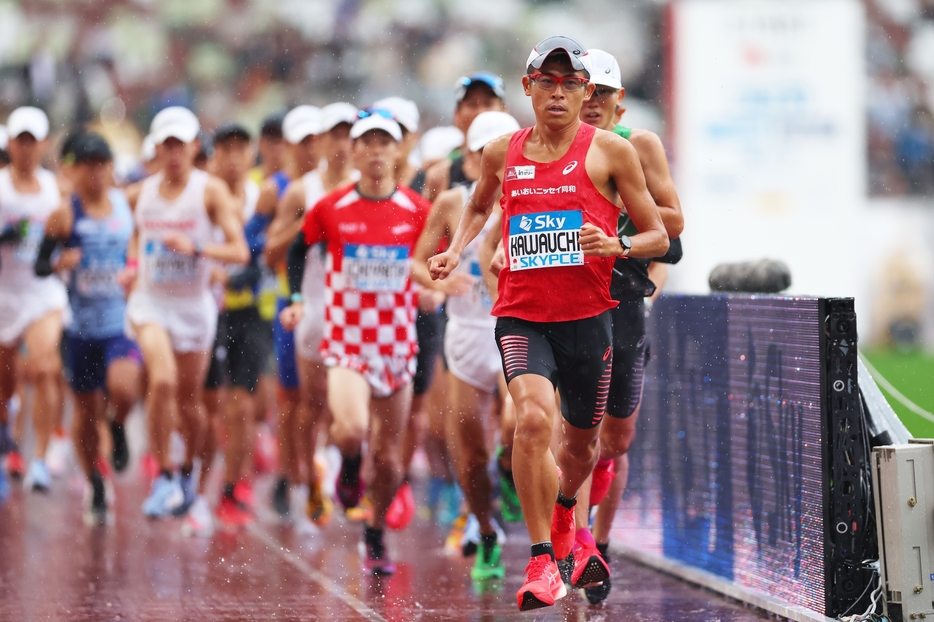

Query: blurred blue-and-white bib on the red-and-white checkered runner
342 244 409 292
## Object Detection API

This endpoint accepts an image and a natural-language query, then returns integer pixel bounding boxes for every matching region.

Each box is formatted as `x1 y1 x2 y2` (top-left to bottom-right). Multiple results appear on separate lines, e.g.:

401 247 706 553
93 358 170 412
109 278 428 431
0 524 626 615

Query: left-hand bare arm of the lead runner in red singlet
428 134 512 279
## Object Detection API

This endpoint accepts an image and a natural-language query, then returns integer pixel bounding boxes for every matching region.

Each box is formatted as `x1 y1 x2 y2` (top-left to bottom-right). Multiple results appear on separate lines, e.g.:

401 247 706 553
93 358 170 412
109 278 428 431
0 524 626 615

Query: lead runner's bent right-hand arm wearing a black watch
579 131 668 257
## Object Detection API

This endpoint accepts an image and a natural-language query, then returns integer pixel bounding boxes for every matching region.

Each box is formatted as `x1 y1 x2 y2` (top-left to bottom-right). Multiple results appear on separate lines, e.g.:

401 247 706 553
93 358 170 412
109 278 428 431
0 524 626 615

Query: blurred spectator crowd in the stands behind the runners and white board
0 0 934 196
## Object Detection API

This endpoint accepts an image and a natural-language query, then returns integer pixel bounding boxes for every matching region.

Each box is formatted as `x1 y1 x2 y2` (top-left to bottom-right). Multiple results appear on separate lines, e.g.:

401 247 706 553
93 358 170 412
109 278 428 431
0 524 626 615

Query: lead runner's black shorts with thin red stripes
496 311 613 430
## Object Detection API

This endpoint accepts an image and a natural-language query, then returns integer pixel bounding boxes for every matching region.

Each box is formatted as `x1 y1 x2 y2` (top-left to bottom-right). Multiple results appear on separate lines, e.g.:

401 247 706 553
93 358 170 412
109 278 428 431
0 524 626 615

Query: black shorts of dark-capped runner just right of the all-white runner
204 307 269 393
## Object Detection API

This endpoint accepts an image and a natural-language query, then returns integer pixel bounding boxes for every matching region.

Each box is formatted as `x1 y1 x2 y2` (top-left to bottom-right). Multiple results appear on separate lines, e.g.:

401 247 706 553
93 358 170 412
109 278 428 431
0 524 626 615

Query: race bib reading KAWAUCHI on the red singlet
509 210 584 270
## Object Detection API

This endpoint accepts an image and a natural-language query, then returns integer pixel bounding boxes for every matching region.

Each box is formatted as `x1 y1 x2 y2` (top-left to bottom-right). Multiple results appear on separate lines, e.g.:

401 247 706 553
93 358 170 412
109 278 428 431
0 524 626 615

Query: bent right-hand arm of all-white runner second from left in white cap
162 177 250 264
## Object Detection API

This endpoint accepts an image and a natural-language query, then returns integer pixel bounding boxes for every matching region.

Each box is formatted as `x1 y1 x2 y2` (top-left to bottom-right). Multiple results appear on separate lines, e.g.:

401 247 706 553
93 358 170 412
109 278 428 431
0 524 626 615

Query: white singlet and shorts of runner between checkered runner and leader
444 184 503 393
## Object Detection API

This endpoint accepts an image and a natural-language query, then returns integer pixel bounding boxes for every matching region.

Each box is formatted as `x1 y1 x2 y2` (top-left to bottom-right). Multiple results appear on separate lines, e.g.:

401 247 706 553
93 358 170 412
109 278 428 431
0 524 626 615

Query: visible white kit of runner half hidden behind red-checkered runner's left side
295 169 360 361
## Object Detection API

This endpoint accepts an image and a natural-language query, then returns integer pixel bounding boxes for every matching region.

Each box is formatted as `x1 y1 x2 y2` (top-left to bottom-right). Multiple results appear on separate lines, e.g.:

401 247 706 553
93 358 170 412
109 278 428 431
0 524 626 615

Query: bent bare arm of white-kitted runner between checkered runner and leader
412 188 473 296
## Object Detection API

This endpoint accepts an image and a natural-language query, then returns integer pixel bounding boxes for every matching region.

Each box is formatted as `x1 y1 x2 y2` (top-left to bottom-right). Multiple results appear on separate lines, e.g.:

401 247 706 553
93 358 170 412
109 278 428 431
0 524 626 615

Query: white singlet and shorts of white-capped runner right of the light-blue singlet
124 169 217 352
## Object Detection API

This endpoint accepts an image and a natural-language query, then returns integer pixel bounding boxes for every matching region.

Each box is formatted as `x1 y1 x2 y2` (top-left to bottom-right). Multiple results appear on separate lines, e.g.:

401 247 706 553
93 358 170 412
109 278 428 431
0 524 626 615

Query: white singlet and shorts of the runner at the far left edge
0 167 69 347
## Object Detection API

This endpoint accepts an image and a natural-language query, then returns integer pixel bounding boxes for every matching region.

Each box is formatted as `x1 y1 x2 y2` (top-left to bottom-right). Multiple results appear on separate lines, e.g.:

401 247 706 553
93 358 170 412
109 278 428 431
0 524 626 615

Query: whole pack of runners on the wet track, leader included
0 36 683 610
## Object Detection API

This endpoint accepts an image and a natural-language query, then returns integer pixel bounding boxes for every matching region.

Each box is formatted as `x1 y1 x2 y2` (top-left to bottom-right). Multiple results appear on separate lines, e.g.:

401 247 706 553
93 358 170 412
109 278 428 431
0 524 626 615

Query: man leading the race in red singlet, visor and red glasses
429 37 668 611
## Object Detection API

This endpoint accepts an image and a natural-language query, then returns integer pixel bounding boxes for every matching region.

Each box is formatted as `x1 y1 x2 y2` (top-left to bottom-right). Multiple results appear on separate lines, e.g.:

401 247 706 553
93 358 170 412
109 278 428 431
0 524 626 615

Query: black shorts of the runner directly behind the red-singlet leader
606 295 649 419
